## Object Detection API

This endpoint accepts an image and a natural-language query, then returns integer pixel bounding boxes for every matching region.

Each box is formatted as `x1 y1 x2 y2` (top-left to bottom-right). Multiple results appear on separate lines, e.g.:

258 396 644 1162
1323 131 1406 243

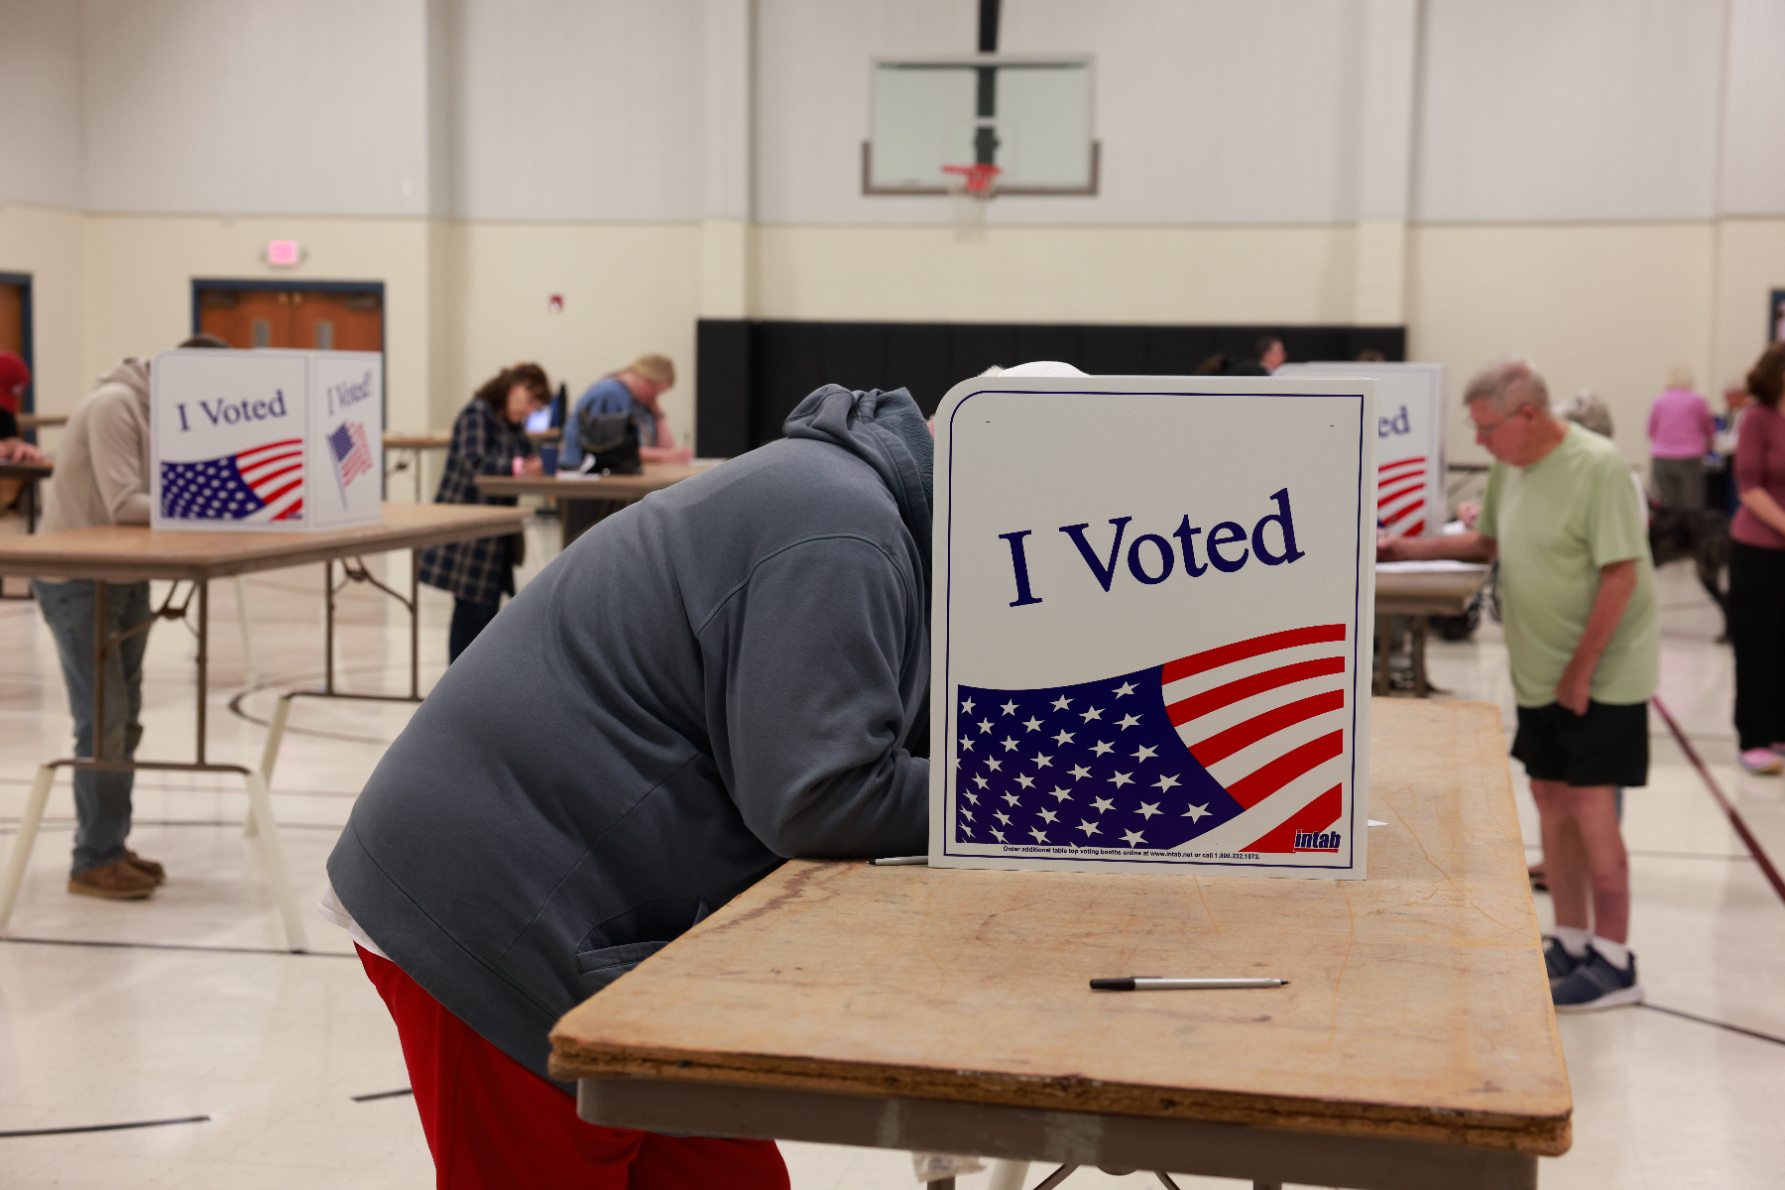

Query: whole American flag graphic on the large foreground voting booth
950 624 1349 858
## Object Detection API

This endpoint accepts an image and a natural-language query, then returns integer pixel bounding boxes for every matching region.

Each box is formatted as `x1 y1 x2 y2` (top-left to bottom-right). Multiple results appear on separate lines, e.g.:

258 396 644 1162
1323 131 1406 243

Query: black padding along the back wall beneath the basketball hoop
694 318 1407 457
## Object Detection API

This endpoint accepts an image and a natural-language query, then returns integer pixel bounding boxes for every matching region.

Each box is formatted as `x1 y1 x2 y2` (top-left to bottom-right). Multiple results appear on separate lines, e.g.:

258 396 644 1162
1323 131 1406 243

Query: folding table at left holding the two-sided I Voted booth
0 505 525 951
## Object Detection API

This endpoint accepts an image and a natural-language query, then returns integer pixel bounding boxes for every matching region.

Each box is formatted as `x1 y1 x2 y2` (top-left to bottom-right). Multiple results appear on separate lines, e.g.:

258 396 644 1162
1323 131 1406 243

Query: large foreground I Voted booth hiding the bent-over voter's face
930 376 1378 878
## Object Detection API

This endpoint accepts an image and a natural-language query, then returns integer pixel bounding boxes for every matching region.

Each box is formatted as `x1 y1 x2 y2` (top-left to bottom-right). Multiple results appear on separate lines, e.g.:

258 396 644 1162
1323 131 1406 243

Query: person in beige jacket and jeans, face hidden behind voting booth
30 335 228 901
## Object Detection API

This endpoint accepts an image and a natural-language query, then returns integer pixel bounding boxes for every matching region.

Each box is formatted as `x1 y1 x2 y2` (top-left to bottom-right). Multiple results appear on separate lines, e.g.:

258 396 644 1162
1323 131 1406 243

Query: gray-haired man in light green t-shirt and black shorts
1376 360 1660 1012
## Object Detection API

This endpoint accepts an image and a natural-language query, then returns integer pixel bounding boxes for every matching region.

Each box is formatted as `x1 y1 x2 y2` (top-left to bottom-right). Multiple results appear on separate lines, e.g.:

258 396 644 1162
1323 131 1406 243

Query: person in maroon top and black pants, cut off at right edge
1730 343 1785 773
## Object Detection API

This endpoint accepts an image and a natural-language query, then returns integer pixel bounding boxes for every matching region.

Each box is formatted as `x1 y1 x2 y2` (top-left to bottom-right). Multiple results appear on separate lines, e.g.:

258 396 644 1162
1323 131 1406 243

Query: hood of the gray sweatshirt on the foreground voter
784 384 935 587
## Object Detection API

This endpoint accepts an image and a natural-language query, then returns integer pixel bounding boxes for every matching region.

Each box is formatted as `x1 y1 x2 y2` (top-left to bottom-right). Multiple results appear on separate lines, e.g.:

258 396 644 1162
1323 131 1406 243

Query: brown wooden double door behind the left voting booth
198 282 384 351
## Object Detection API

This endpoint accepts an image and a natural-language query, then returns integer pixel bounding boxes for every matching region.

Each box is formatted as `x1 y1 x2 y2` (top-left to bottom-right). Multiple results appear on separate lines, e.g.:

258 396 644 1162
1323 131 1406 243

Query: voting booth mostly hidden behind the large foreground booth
1276 364 1449 537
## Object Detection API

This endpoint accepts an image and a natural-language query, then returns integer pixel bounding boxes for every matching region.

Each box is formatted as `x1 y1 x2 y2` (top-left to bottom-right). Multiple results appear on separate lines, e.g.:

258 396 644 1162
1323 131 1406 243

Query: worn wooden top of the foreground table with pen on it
552 699 1573 1154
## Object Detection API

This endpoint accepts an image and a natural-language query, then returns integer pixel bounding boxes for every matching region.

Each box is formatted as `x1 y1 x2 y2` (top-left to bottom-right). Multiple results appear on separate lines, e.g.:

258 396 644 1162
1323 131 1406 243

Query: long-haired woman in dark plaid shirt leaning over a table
416 364 552 664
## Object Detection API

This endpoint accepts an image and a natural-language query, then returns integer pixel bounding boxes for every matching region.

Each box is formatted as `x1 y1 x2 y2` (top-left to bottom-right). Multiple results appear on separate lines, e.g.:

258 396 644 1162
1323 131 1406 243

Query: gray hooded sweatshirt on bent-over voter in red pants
328 385 932 1076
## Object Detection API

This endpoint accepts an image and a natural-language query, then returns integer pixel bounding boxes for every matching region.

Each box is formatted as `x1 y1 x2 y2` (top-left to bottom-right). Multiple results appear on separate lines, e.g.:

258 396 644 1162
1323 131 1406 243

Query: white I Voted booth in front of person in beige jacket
150 350 384 530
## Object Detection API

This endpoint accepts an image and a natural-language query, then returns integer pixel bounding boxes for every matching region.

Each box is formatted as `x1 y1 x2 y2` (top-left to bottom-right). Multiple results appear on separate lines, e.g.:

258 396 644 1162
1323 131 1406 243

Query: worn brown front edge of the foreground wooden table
550 1031 1573 1156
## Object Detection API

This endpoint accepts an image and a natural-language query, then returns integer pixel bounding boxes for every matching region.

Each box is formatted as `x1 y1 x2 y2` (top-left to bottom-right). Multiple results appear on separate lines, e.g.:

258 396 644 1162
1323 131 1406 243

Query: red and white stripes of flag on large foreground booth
1160 624 1349 851
